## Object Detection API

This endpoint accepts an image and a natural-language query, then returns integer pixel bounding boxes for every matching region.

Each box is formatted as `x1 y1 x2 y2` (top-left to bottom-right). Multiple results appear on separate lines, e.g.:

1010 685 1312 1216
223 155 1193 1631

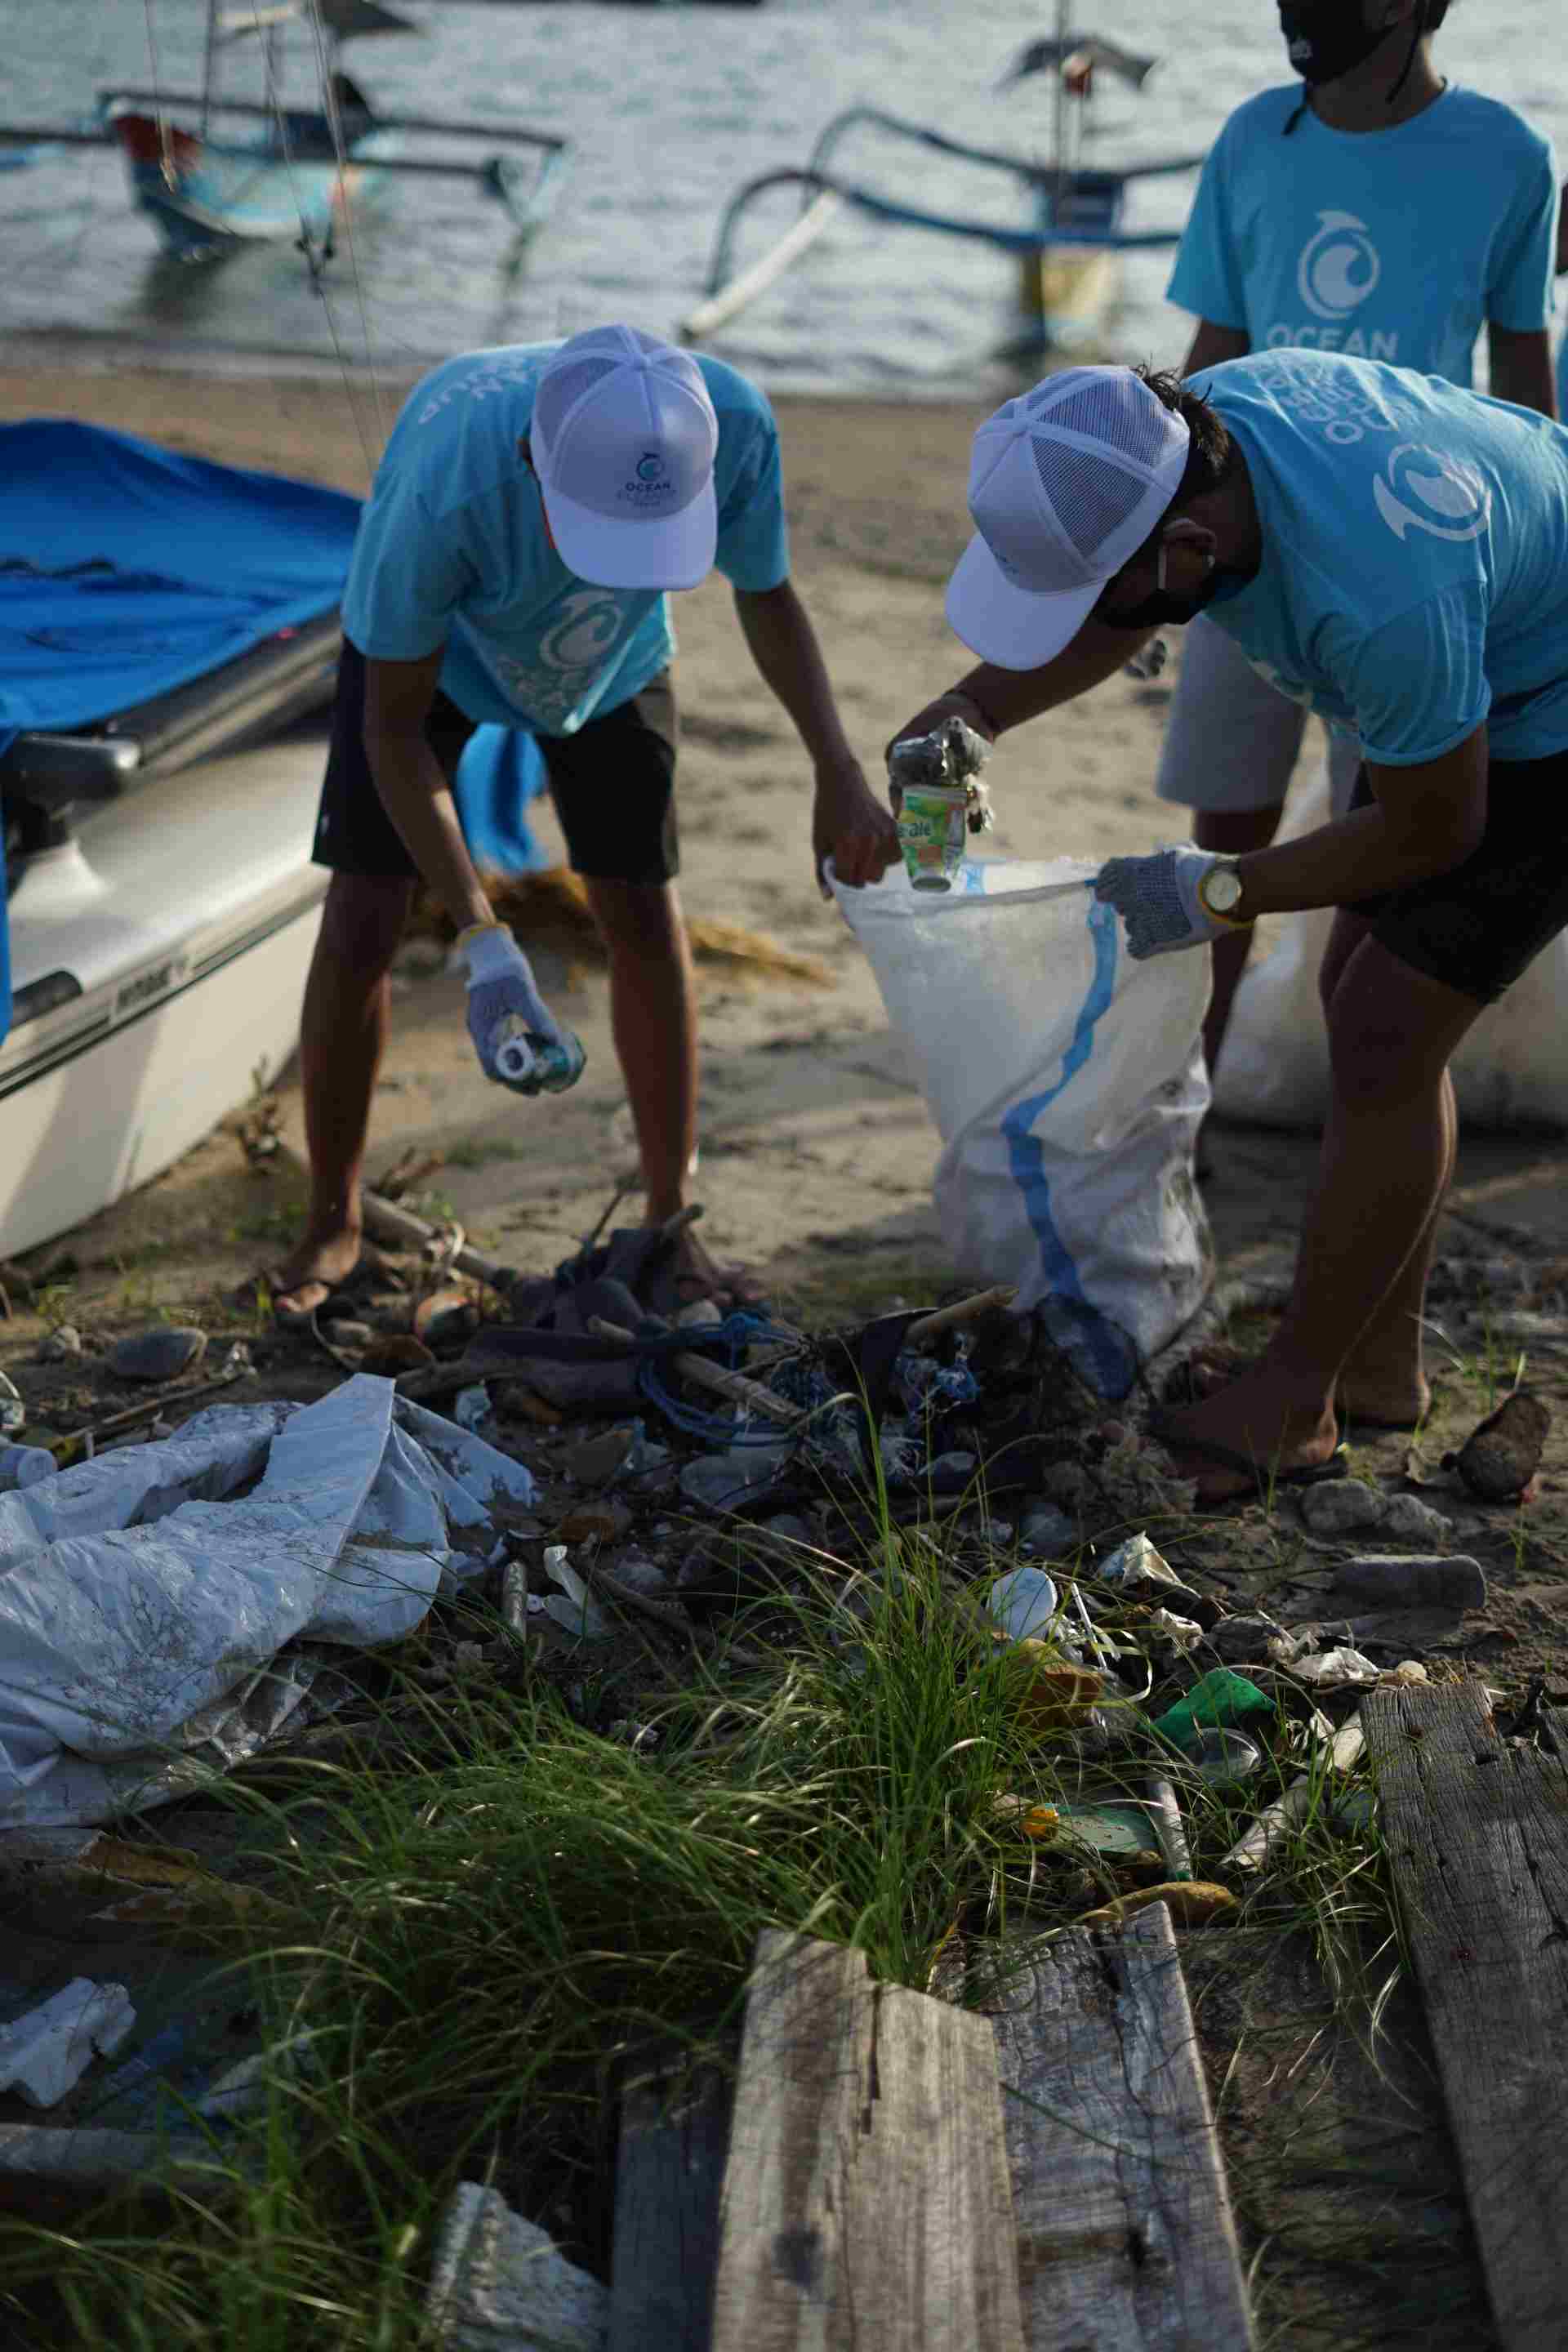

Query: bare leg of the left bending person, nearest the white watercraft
273 875 414 1315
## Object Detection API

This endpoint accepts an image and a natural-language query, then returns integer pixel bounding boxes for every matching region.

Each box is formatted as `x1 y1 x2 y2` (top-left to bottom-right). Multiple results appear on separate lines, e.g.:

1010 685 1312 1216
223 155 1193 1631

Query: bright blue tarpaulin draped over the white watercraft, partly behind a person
0 419 546 1037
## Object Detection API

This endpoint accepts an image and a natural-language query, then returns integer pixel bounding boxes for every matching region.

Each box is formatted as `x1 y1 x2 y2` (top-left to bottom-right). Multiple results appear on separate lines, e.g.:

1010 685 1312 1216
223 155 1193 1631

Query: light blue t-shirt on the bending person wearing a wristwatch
1194 350 1568 767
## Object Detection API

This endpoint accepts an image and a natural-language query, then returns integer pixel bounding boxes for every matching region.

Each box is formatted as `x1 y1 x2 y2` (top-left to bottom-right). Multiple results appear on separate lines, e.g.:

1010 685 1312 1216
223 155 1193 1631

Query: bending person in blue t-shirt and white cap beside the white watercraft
268 327 898 1322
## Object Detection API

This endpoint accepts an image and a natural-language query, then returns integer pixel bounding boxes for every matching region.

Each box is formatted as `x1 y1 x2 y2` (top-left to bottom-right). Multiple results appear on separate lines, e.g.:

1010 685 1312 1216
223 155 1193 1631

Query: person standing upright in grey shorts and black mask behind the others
1154 0 1557 1070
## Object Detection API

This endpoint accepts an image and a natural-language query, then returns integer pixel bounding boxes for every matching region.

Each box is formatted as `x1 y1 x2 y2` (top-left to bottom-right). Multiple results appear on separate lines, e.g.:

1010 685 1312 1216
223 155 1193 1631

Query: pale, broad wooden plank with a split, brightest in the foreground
712 1933 1022 2352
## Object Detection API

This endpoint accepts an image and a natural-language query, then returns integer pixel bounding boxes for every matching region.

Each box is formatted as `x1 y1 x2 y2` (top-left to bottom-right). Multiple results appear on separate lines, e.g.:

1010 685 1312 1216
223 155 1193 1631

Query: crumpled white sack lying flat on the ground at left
0 1374 536 1842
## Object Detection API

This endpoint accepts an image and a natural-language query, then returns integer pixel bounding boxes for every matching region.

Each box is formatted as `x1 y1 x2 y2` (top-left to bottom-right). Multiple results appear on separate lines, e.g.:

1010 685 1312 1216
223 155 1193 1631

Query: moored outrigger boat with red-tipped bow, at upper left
0 0 567 268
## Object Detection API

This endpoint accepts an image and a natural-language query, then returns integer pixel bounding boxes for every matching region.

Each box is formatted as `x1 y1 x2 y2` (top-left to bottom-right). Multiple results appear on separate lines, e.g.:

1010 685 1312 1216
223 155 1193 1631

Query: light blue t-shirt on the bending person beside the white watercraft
343 343 790 736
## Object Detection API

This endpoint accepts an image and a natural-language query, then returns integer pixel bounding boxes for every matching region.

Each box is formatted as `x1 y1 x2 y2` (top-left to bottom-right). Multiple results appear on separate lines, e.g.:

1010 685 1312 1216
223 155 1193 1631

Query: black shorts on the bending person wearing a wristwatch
1347 753 1568 1004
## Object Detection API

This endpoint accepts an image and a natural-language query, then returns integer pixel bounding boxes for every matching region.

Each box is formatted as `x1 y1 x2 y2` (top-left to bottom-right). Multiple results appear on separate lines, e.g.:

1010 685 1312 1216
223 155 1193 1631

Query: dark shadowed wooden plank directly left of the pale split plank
607 2044 731 2352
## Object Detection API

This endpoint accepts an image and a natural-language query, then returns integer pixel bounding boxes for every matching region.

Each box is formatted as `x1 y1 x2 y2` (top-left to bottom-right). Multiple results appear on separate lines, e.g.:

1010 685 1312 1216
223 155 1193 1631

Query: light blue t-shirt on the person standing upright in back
1169 82 1557 383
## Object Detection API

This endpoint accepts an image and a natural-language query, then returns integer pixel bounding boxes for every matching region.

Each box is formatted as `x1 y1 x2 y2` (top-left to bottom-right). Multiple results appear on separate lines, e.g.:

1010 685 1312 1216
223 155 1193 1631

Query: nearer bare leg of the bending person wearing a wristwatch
1169 938 1481 1500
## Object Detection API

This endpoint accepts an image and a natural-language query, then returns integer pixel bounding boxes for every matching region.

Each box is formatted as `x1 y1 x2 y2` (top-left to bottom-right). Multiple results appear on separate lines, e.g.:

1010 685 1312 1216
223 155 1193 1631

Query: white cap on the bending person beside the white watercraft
529 327 719 588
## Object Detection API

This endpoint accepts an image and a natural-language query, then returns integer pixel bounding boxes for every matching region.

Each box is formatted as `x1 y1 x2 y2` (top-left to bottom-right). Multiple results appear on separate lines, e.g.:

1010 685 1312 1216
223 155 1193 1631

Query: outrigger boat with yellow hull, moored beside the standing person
679 0 1204 358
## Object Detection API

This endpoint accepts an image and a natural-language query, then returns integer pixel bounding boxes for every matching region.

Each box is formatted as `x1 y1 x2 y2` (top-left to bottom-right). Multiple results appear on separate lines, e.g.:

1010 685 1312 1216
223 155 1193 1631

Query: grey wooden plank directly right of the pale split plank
985 1903 1253 2352
